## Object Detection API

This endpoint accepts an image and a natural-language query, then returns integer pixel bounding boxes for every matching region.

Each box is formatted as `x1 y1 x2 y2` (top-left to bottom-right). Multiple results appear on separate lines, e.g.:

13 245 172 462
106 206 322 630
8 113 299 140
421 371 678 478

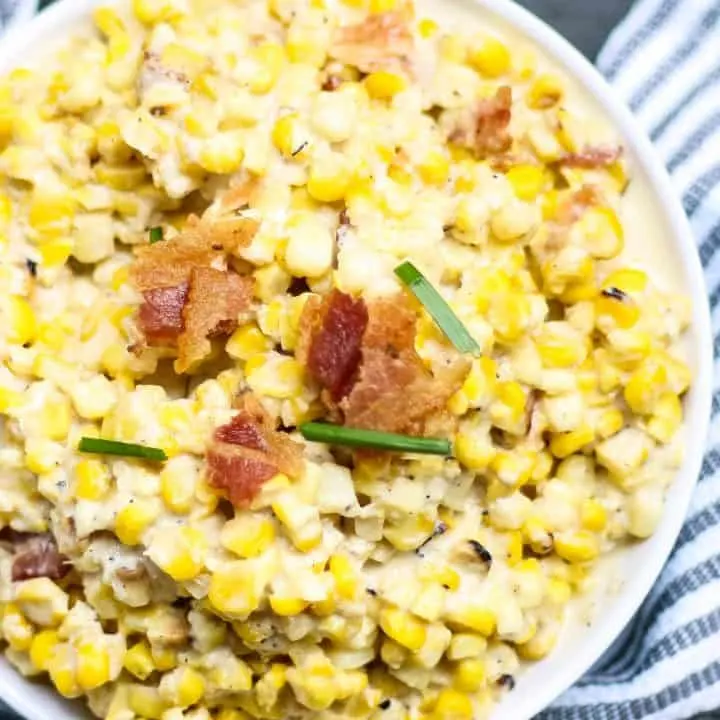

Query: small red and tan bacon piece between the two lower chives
207 395 302 507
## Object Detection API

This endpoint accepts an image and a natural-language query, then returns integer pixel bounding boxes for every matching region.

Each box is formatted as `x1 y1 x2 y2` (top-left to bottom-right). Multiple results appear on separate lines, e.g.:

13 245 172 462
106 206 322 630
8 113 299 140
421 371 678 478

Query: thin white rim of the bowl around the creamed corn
0 0 713 720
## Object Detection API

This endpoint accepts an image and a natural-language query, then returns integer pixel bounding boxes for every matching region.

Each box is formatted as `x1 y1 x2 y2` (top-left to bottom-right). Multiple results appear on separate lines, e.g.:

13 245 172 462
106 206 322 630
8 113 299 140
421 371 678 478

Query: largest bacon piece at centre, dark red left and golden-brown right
298 290 467 435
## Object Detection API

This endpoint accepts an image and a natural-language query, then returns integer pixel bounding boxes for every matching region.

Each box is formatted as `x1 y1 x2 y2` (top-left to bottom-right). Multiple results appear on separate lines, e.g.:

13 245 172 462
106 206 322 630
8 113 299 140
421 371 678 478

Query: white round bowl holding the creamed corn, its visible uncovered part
0 0 712 720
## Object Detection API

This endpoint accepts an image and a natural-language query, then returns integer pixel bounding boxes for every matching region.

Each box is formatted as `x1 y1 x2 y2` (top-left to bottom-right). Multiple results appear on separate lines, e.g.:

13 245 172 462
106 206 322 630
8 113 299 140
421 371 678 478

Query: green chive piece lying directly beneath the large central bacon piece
300 423 451 455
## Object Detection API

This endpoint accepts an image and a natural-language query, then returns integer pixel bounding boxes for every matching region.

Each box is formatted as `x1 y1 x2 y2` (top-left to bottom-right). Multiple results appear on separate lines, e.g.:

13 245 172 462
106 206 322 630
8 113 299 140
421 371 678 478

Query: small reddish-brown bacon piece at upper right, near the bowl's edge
450 86 512 158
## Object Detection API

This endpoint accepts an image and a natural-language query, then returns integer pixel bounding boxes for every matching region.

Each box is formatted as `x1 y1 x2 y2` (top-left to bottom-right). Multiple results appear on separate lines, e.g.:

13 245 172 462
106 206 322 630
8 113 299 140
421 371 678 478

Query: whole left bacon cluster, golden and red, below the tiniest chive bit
131 183 258 373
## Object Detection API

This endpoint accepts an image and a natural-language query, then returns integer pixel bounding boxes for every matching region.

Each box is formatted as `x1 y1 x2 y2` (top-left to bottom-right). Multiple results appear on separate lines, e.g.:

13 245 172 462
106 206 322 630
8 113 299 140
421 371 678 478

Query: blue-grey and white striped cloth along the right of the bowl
538 0 720 720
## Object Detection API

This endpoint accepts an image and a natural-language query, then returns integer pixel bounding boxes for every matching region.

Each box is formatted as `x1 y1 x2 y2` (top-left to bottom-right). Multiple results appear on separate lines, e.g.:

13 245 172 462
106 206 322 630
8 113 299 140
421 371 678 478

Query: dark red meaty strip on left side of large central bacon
304 290 368 402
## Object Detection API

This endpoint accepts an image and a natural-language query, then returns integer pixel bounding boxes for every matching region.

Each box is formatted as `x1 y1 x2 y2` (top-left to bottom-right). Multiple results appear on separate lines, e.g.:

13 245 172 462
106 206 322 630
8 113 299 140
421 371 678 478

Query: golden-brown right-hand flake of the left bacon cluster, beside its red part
175 267 253 373
